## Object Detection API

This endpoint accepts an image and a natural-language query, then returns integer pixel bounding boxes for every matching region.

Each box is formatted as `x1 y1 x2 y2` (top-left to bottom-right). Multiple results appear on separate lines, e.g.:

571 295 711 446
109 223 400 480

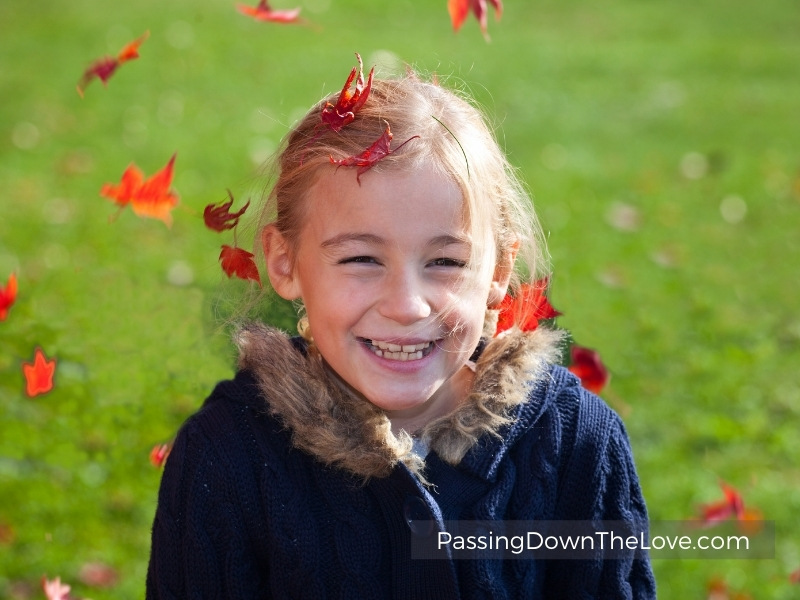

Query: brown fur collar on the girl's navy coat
236 324 563 481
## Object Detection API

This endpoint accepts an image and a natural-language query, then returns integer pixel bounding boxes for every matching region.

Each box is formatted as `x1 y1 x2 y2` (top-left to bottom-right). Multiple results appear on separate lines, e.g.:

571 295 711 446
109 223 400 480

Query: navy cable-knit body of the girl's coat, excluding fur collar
147 367 655 600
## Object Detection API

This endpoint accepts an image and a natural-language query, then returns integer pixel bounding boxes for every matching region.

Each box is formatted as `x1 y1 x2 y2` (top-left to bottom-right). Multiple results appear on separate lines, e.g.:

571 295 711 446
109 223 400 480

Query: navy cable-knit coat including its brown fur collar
147 327 655 600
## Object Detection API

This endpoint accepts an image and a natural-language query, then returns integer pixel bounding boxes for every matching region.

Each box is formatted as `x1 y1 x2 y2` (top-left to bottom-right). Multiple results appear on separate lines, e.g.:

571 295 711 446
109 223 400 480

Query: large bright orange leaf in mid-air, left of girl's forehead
100 154 178 227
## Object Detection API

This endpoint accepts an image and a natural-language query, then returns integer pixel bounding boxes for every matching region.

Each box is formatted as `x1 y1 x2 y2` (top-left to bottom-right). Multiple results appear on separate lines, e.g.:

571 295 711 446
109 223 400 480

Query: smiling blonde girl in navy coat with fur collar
147 62 655 600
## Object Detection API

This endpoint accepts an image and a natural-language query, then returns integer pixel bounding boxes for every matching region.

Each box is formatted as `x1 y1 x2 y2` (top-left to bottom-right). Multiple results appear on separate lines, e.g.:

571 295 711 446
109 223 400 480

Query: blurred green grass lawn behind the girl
0 0 800 600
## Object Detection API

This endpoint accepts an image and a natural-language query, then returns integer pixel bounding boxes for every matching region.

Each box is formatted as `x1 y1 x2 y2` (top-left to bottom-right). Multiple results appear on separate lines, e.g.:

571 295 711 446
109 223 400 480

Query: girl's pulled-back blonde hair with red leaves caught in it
250 73 548 330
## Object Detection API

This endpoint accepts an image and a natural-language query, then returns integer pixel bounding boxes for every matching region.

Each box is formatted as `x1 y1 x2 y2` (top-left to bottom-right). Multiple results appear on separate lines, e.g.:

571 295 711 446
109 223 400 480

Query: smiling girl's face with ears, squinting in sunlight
263 166 507 432
